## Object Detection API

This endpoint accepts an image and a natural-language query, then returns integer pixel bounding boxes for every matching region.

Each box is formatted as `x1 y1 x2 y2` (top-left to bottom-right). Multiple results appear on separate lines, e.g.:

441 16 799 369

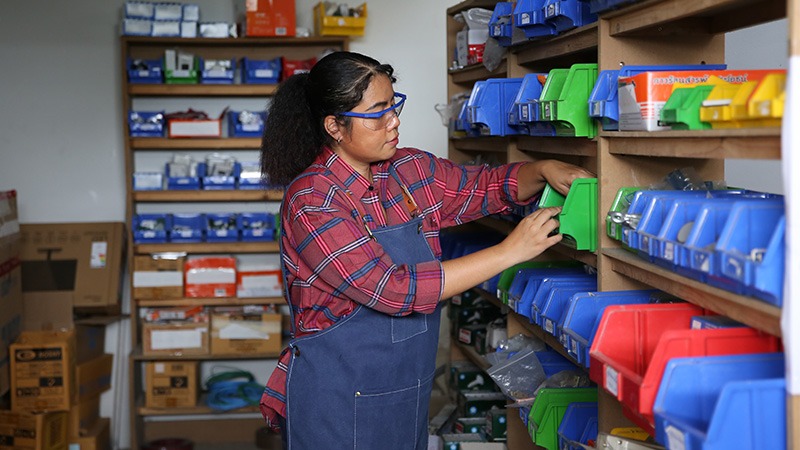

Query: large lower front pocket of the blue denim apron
353 385 418 450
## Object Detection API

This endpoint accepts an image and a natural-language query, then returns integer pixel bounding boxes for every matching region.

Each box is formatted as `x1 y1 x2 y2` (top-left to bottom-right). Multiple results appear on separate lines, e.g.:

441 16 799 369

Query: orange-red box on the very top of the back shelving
245 0 297 36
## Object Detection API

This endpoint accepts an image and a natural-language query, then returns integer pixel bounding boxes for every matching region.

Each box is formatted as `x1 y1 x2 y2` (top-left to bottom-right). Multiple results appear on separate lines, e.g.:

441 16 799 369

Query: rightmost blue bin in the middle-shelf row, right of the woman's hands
708 201 784 295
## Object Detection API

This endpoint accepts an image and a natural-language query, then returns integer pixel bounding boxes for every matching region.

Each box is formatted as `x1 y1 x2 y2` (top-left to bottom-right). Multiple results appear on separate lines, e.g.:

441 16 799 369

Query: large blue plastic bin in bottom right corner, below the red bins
654 353 786 450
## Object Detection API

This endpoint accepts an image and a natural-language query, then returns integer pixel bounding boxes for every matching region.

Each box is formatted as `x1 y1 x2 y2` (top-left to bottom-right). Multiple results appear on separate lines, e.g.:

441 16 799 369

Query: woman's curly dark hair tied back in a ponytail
261 52 396 186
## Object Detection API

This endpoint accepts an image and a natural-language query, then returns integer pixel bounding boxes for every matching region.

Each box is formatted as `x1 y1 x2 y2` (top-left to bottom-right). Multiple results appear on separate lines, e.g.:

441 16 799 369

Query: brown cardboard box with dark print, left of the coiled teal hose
144 361 199 408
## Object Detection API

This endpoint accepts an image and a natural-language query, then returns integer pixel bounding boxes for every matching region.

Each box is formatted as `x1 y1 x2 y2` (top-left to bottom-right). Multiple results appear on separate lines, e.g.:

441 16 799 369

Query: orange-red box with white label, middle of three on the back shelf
183 256 236 298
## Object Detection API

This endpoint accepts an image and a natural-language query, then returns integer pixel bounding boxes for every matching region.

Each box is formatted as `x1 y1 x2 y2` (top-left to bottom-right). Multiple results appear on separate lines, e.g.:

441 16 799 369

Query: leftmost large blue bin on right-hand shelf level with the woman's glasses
467 78 522 136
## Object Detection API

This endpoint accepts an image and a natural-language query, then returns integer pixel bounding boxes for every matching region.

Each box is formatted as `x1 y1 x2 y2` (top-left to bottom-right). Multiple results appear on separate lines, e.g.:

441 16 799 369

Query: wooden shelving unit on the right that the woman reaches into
446 0 800 450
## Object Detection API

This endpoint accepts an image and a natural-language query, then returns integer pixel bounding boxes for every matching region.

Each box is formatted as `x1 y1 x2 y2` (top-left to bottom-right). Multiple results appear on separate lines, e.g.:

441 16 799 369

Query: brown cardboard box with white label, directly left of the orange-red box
133 255 186 300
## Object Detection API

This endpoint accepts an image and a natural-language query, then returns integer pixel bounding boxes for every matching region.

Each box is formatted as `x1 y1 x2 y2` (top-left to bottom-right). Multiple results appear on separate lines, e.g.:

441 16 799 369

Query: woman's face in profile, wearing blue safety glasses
334 75 400 181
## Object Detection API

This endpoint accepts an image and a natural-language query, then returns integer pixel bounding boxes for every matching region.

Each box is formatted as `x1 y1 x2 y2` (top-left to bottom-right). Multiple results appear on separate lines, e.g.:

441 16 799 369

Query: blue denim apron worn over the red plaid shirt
285 173 441 450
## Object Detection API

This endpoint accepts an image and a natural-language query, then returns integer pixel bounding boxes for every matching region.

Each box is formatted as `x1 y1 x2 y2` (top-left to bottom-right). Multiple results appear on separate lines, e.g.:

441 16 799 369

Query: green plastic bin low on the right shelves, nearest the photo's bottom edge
528 388 597 450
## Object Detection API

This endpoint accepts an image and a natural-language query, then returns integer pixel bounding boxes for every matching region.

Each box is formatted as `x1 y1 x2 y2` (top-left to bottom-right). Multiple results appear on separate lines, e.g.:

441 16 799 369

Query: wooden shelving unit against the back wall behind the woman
120 37 349 449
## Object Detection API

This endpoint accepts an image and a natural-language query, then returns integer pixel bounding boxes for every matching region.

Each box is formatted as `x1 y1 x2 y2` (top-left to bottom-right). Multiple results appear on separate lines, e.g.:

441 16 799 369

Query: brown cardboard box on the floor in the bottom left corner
0 411 67 450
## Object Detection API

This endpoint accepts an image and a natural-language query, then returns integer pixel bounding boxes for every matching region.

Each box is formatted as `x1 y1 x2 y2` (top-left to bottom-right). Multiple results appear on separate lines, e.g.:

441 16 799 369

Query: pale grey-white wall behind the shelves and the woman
0 0 787 447
